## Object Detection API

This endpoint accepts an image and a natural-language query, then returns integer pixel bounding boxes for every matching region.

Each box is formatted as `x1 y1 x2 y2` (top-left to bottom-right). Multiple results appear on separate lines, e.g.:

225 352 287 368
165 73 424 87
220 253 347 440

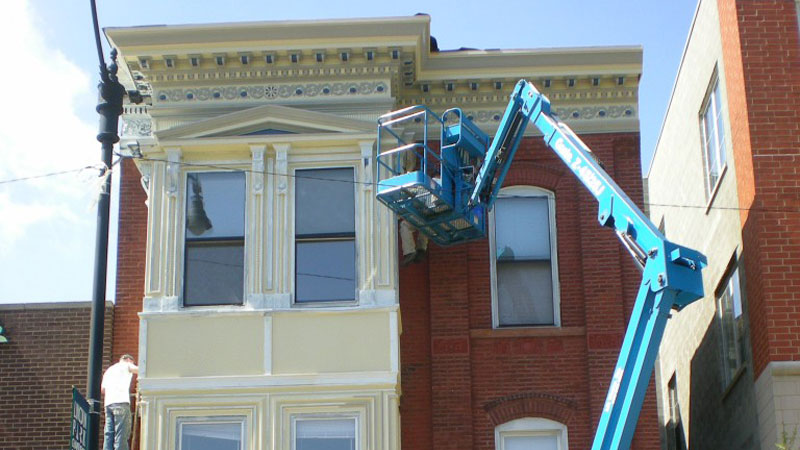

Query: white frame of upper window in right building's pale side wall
698 74 728 202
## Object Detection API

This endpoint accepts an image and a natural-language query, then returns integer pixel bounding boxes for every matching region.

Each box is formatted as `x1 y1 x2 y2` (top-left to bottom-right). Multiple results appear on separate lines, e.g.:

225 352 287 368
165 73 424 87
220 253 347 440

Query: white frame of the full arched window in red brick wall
489 186 561 328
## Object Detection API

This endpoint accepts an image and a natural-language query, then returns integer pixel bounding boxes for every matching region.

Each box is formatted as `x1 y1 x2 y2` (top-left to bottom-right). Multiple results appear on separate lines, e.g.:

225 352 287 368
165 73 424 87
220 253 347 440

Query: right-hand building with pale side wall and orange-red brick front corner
649 0 800 449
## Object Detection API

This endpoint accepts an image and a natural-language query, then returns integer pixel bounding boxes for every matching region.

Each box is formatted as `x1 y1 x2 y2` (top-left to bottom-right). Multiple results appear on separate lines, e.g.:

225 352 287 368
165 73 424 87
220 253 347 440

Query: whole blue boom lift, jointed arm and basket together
376 80 706 450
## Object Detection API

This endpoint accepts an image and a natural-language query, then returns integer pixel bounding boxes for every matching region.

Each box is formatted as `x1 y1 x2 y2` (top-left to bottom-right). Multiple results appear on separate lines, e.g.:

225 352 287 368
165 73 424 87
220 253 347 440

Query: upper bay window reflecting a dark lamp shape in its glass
183 172 245 306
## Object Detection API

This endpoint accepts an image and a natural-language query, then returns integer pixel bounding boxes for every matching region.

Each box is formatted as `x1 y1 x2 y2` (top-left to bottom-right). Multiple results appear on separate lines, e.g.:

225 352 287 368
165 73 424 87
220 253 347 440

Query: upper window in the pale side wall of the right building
700 76 725 199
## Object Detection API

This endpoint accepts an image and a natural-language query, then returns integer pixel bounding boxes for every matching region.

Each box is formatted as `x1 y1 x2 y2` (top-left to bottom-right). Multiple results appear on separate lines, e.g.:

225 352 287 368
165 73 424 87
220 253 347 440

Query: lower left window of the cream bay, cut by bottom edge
176 416 246 450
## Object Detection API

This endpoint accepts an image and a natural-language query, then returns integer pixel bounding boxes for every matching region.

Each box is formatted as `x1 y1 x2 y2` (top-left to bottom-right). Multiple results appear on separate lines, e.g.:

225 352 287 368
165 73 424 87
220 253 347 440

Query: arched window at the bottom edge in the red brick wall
494 417 569 450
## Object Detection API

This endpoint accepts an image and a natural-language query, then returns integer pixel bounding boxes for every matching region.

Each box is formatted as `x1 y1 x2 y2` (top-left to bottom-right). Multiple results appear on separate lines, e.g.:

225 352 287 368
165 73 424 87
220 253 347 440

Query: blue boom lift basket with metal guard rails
377 106 489 245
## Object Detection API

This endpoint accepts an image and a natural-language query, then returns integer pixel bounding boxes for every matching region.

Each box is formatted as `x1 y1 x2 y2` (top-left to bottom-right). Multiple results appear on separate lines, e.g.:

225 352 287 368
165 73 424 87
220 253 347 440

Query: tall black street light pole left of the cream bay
86 0 125 450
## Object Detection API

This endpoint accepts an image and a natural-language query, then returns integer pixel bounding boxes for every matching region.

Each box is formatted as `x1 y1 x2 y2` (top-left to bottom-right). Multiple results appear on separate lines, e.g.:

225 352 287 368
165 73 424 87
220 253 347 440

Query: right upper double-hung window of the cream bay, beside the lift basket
295 168 356 303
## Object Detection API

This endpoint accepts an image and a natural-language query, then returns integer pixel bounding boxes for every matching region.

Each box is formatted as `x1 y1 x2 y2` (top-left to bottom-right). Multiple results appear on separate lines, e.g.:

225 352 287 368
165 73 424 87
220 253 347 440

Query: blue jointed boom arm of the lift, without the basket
469 80 706 450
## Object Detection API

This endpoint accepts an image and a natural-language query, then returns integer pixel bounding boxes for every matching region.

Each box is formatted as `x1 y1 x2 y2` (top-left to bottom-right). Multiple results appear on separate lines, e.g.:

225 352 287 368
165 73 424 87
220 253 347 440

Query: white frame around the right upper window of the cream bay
288 162 362 308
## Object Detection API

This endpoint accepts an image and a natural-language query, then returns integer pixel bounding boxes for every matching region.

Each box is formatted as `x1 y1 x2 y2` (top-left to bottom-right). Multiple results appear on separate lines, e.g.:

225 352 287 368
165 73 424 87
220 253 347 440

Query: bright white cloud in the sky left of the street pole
0 0 99 246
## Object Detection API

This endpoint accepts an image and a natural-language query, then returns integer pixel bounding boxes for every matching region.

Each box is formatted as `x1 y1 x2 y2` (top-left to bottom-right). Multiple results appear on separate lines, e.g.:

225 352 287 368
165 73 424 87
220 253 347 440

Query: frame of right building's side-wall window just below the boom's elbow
715 261 746 389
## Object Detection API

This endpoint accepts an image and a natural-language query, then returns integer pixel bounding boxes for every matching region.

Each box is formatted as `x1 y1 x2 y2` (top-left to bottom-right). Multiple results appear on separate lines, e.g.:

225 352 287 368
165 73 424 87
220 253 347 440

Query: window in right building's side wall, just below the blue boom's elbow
717 266 745 386
